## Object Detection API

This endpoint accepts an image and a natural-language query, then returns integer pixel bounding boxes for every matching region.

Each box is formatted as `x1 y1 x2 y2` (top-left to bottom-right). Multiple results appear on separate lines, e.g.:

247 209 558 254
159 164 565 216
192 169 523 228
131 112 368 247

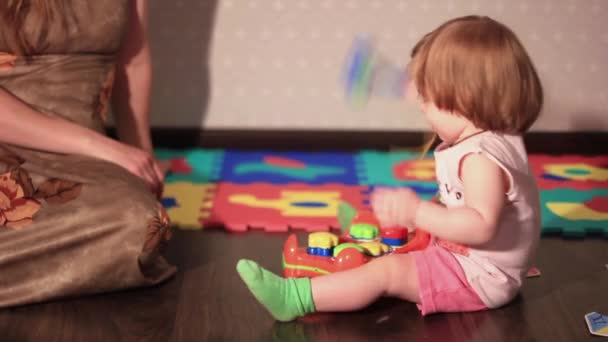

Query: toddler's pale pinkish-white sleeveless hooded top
435 132 540 308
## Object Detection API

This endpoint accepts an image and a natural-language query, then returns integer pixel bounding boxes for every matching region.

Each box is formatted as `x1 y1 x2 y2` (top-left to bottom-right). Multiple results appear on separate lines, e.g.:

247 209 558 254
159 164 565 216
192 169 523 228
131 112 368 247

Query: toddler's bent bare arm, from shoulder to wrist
415 153 508 245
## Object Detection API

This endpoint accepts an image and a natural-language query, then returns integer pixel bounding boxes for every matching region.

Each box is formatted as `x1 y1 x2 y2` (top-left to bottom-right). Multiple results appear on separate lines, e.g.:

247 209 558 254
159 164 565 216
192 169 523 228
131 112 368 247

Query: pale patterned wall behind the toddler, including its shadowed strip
150 0 608 131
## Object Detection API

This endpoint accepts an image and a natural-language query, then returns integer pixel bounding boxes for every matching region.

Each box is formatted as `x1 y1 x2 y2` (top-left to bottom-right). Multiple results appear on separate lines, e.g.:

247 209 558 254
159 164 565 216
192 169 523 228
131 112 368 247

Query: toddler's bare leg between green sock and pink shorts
311 254 420 312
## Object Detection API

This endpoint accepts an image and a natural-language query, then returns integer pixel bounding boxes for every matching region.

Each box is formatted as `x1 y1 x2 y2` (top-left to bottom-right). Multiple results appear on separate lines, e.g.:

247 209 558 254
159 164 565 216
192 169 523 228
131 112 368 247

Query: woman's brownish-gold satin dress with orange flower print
0 0 175 307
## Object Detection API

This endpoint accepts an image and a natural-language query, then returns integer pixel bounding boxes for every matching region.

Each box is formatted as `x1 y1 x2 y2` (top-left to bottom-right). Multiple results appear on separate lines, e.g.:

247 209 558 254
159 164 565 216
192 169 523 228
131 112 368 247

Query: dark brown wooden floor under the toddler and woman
0 230 608 342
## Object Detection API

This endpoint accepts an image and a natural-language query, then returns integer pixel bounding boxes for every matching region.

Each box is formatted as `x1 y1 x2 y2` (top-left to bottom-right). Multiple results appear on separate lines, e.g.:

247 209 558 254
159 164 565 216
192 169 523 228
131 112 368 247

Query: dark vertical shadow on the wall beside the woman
149 0 218 127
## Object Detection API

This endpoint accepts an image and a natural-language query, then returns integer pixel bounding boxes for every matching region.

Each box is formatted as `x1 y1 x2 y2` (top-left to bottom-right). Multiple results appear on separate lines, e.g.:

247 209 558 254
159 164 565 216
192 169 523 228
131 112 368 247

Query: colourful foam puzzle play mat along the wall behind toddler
156 149 608 238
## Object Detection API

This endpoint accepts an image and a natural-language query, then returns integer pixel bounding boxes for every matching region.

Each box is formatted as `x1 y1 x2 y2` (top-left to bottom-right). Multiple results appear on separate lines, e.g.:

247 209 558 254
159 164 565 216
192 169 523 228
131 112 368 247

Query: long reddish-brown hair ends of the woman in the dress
0 0 70 55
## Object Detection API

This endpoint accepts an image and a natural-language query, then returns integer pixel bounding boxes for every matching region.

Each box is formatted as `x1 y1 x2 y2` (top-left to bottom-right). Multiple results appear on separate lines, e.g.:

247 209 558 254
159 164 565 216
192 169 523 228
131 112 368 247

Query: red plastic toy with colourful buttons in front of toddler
283 203 430 278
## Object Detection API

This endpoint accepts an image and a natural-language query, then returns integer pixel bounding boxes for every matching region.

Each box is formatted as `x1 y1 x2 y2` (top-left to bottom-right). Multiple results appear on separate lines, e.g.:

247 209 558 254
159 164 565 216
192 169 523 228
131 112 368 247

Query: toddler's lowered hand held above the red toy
372 188 421 229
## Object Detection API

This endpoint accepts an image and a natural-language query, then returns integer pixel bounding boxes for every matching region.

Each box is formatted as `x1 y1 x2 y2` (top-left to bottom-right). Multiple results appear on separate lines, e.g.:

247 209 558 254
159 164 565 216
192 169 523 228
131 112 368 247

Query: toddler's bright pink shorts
411 245 487 316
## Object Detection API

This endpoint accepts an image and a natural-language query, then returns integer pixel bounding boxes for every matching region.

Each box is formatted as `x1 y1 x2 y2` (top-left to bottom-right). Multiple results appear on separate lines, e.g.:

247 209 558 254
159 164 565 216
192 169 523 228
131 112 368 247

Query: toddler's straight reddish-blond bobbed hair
409 16 543 133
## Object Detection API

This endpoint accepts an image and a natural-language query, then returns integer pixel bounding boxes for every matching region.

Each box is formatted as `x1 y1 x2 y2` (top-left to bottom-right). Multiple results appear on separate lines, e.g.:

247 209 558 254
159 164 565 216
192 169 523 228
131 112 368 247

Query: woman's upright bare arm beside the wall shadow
112 0 152 152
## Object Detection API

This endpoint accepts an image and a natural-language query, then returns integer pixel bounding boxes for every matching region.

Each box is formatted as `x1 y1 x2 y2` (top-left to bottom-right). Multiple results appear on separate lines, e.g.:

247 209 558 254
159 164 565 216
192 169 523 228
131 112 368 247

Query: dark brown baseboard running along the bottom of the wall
115 128 608 155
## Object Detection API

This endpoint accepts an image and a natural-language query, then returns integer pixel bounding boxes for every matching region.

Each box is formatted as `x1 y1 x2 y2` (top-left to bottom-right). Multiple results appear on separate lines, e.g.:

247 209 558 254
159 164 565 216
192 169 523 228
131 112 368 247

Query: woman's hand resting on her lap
98 141 165 198
